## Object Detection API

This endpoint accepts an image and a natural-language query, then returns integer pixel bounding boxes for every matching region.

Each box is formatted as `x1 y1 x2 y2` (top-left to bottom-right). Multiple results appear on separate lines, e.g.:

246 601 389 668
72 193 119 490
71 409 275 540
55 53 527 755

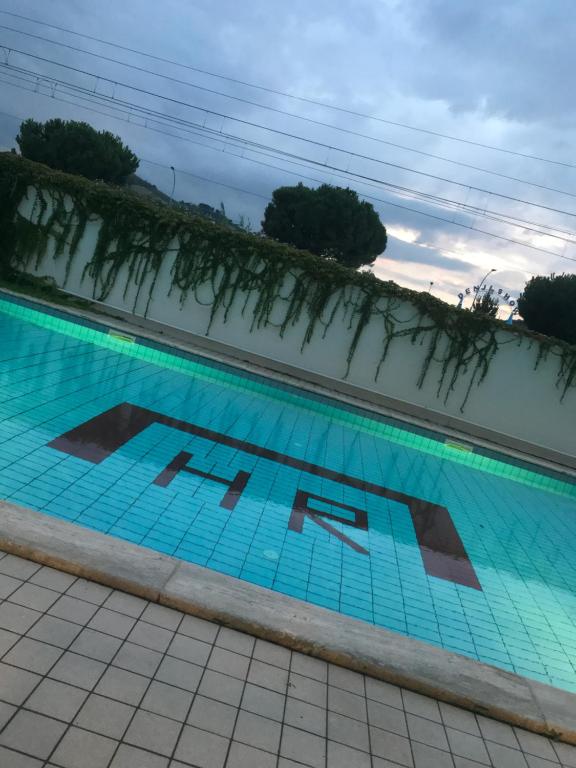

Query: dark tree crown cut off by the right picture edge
518 275 576 344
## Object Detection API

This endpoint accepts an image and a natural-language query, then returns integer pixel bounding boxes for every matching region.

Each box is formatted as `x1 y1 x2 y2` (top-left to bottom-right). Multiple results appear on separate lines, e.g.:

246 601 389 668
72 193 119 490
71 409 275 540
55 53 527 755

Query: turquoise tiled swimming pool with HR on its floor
0 295 576 691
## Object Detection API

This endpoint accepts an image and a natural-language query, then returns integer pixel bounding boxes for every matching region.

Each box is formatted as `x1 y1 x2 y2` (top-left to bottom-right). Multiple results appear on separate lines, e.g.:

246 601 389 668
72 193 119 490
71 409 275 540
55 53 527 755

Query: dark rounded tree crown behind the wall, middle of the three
262 183 386 268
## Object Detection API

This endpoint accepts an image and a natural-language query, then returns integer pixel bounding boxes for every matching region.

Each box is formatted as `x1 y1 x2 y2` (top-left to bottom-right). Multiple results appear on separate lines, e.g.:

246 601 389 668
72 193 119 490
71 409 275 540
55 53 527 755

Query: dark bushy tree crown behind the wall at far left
16 119 139 184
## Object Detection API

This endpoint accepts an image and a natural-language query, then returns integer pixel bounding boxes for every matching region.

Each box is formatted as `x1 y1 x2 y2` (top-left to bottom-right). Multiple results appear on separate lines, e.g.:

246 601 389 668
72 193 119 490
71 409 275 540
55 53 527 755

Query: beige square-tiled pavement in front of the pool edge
0 553 576 768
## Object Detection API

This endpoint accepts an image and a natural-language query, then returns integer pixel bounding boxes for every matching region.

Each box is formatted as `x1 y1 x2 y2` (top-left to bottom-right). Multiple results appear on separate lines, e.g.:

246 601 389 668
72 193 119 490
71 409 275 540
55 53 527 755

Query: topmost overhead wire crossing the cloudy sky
0 10 576 168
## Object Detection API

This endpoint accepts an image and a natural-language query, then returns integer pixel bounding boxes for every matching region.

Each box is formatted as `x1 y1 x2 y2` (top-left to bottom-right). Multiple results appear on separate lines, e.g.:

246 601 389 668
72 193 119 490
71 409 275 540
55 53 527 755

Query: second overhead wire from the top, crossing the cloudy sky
0 24 576 197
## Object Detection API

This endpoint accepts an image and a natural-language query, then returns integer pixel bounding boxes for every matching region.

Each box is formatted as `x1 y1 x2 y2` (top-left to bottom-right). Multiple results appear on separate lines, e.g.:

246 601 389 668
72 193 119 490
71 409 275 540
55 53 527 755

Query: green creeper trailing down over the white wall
0 153 576 410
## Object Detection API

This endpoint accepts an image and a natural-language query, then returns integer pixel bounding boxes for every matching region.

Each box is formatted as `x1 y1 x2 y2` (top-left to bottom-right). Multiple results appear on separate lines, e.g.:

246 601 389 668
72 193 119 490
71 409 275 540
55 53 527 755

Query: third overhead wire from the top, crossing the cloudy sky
2 44 576 225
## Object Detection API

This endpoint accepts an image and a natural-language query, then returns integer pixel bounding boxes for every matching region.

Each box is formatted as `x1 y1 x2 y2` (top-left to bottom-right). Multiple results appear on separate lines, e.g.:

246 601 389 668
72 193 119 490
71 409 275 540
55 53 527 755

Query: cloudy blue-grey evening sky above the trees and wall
0 0 576 302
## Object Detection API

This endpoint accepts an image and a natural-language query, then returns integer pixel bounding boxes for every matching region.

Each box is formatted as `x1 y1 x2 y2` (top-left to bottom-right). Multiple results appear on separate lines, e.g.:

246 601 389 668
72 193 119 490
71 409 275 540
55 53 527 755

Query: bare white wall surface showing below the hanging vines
14 188 576 464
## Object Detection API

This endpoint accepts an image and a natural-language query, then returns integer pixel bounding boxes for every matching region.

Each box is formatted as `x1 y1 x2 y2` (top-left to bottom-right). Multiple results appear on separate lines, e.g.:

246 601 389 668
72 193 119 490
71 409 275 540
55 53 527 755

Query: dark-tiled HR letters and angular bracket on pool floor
49 403 482 590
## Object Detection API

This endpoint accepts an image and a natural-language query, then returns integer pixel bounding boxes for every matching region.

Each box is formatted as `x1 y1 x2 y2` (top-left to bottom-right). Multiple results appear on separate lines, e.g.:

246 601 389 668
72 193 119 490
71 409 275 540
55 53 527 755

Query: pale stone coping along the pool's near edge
0 501 576 745
